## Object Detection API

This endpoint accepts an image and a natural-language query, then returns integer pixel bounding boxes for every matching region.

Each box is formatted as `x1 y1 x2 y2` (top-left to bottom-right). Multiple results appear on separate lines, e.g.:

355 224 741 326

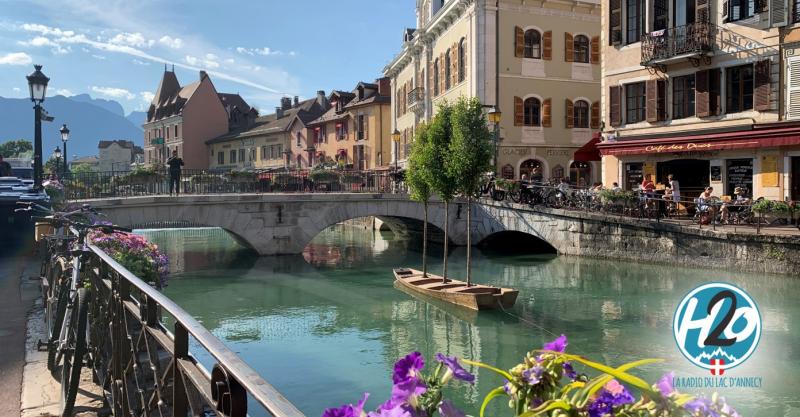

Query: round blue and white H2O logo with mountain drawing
672 282 761 375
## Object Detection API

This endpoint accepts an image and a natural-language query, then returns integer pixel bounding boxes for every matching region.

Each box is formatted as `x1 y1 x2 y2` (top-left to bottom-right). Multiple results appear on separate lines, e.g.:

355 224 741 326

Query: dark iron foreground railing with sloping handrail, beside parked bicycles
86 246 303 417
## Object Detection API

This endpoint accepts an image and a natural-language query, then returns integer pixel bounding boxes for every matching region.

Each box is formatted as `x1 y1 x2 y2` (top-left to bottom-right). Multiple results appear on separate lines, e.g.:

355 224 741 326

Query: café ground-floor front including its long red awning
598 124 800 200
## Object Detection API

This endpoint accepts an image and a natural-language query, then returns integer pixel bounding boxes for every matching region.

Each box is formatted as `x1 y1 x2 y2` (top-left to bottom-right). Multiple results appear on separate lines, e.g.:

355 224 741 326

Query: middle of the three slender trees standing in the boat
427 101 456 282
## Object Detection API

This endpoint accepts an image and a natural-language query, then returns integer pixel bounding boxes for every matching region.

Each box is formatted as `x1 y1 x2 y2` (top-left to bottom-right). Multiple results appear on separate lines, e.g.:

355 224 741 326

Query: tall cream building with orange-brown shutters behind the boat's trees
384 0 600 183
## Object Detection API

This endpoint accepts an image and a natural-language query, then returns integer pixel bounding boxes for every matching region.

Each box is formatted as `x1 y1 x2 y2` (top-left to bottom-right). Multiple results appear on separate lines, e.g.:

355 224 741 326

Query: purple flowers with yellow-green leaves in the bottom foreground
322 335 740 417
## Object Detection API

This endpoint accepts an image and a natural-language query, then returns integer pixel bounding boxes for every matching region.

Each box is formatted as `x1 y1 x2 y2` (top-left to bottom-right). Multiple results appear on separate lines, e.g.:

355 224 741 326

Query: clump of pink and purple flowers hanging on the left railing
89 231 169 289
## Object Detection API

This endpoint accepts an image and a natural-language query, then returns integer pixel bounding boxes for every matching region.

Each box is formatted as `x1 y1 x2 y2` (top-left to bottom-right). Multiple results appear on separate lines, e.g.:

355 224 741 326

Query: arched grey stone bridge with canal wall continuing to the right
85 193 800 273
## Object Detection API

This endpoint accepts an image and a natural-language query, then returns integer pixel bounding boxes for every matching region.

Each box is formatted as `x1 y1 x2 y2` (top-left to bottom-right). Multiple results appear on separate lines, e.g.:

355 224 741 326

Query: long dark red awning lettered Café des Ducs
597 127 800 155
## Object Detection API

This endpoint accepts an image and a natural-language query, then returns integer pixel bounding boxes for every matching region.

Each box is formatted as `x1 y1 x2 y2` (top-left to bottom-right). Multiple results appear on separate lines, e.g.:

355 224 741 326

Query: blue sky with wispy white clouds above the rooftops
0 0 415 114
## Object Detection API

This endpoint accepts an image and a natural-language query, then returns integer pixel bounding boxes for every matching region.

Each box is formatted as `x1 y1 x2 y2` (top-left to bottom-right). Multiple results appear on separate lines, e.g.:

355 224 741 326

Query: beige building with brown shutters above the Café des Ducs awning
598 0 800 199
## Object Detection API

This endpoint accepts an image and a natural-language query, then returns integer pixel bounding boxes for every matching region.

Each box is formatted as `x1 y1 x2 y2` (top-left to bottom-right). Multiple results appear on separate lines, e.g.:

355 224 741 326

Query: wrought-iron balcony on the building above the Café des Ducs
642 22 717 68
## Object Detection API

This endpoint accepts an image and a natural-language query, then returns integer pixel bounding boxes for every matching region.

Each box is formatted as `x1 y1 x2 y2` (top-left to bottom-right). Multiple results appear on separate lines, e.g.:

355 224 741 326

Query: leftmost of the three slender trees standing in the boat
406 123 436 277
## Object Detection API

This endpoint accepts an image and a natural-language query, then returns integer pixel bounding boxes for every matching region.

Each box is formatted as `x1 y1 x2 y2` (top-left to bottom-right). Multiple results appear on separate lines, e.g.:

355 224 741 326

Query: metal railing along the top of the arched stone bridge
63 169 405 200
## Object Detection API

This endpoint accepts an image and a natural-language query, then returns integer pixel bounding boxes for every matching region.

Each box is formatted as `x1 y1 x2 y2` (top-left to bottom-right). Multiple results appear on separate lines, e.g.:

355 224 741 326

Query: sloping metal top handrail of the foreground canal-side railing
89 244 304 417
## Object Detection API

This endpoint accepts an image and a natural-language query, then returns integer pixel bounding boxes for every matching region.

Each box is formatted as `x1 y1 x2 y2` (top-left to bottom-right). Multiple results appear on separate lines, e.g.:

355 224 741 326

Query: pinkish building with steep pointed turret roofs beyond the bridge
143 68 258 169
